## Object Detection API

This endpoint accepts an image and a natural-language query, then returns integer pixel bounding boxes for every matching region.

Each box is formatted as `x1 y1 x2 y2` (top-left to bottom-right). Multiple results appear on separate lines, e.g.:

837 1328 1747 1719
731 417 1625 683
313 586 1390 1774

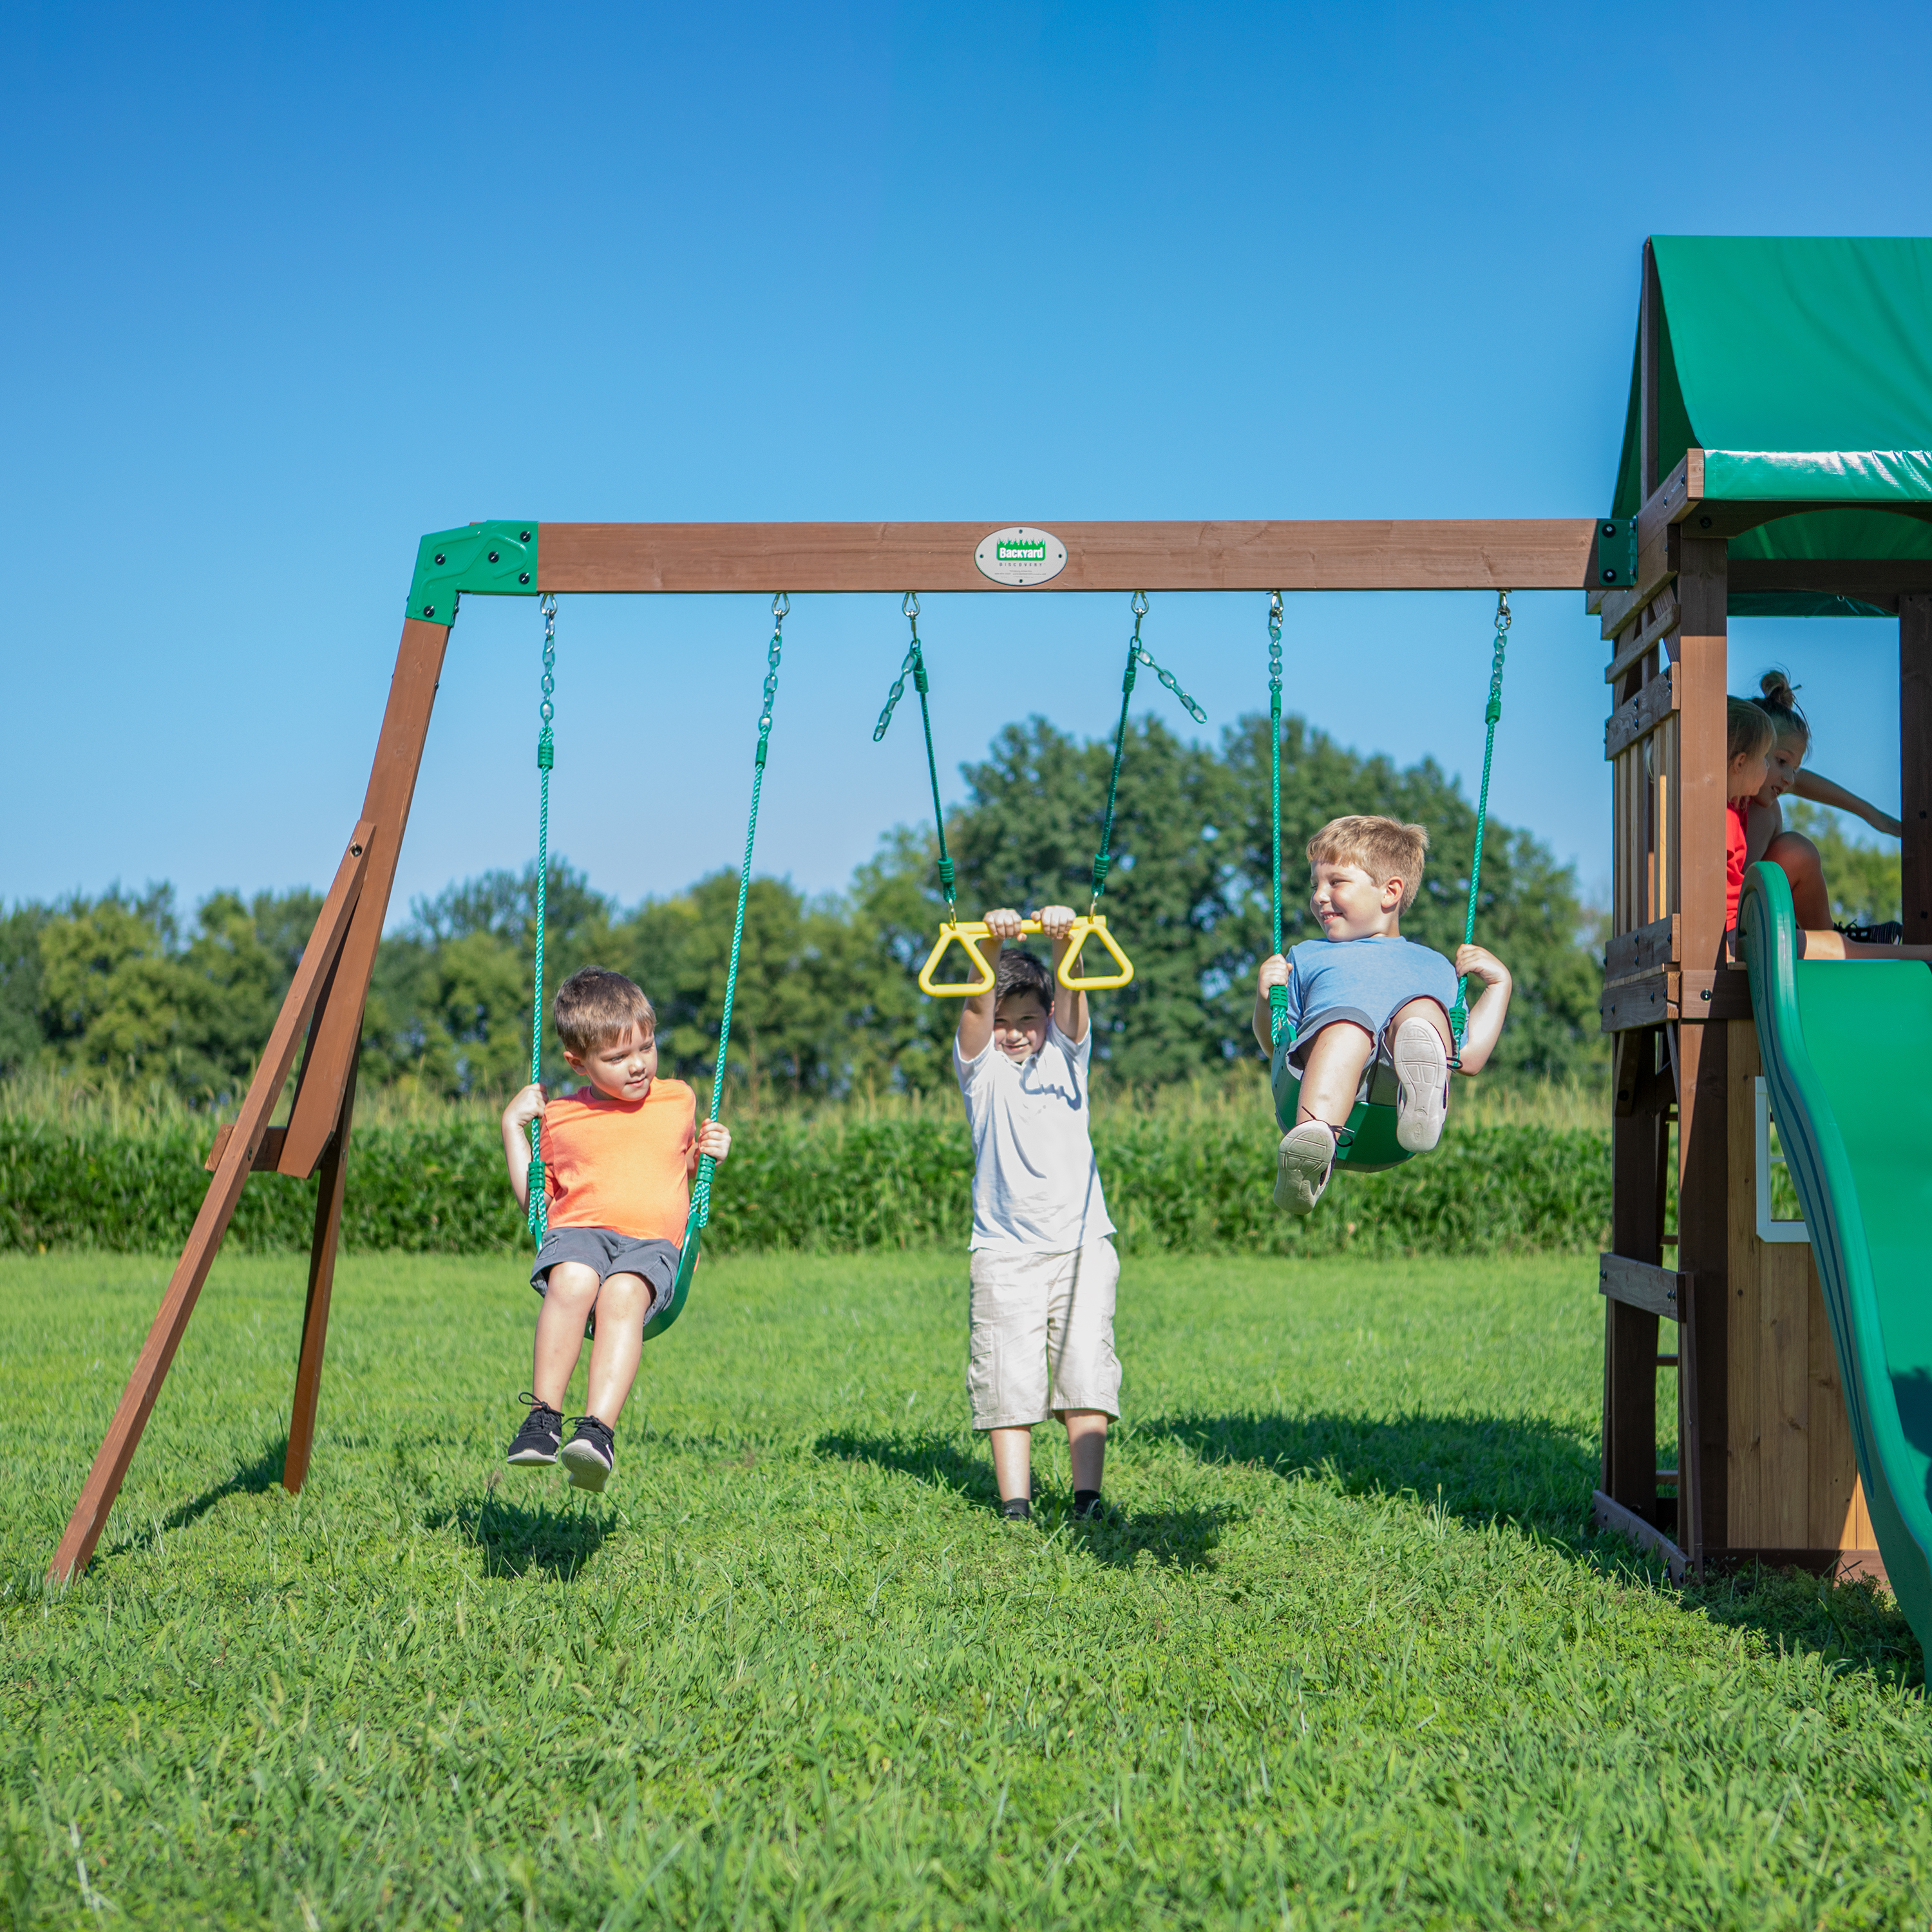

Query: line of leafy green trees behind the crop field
0 717 1602 1105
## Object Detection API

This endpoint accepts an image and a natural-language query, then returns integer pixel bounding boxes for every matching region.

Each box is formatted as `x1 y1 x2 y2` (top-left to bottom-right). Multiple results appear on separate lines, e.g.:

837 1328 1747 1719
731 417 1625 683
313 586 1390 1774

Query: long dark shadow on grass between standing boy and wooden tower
1132 1412 1596 1546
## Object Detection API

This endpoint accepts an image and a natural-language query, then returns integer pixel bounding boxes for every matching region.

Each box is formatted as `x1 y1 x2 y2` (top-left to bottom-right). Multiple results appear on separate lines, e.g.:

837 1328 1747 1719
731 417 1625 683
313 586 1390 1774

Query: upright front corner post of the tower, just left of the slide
1673 537 1729 1565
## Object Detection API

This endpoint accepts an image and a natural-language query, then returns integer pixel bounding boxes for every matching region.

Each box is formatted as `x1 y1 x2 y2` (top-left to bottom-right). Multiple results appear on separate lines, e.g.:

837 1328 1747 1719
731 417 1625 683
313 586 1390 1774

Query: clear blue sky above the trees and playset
0 0 1932 916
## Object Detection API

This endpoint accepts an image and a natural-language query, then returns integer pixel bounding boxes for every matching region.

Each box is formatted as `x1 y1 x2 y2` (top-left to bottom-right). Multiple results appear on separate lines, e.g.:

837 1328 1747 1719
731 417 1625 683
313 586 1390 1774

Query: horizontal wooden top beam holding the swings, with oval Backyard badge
537 518 1596 595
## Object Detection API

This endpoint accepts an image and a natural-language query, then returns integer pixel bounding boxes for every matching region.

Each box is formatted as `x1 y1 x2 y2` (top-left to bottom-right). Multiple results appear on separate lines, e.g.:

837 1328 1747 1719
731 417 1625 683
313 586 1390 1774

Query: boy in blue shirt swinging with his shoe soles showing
1254 817 1511 1213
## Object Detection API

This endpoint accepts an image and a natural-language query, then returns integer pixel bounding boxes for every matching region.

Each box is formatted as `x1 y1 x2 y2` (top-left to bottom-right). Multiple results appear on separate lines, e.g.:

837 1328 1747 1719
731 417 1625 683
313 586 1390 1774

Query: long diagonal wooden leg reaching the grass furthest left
48 819 375 1582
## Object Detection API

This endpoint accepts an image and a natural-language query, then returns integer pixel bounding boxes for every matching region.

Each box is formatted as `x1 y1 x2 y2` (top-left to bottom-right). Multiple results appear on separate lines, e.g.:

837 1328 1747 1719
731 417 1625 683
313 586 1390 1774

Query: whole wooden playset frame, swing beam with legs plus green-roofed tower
50 243 1932 1607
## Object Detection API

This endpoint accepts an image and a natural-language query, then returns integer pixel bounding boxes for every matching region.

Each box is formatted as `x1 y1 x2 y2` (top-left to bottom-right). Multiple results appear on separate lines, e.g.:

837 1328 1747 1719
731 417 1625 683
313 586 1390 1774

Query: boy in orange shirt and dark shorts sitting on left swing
502 966 730 1490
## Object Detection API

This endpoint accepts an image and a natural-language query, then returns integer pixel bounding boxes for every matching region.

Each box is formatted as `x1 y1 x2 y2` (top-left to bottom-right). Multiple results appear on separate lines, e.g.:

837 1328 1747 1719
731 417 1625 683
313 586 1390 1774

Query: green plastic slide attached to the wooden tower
1737 866 1932 1650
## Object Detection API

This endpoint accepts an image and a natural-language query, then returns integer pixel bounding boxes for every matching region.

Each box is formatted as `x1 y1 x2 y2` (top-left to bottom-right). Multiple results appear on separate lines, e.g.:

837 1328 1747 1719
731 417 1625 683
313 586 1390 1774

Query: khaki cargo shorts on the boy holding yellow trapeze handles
966 1240 1121 1430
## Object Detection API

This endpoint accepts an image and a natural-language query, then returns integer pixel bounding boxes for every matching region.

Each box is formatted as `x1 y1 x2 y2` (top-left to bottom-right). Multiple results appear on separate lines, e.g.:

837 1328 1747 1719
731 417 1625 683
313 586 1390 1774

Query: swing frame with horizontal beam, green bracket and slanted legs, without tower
50 518 1596 1580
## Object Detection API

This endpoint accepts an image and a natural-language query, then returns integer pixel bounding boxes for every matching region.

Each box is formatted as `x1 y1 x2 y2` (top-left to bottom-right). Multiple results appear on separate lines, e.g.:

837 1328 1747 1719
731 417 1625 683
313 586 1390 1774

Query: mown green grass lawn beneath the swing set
0 1254 1932 1928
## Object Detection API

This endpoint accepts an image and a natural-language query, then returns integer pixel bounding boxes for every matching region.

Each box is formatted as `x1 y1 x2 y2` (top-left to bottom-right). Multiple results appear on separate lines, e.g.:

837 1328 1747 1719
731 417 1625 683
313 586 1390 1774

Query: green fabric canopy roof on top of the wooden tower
1611 236 1932 614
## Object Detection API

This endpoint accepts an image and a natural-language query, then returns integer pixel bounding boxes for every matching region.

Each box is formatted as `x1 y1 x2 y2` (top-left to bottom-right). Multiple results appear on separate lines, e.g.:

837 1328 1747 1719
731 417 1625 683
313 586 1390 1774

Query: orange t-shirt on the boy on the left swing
541 1080 697 1242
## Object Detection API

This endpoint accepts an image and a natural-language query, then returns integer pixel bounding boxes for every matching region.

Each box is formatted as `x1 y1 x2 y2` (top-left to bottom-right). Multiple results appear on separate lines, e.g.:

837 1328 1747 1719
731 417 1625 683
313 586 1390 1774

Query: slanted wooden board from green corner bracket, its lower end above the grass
280 618 450 1177
